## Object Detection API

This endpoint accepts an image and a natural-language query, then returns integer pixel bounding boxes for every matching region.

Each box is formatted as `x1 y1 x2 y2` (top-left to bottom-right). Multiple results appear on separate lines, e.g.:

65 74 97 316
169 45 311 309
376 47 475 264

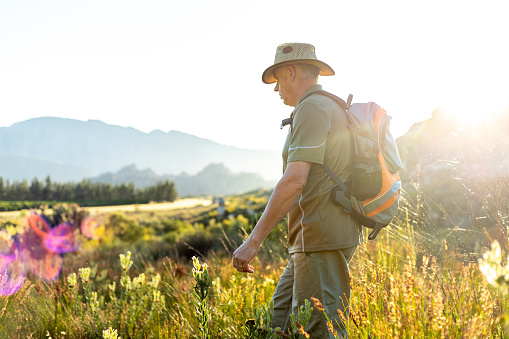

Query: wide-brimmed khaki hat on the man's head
262 43 335 84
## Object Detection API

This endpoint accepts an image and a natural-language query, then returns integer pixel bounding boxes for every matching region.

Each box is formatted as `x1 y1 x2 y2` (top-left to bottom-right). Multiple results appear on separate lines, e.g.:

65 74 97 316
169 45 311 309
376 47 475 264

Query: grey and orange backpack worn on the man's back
304 91 403 240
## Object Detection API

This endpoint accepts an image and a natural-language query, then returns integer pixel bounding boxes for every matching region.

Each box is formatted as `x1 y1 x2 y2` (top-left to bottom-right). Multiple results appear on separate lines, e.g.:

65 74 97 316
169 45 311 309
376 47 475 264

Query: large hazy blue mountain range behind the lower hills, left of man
0 117 281 181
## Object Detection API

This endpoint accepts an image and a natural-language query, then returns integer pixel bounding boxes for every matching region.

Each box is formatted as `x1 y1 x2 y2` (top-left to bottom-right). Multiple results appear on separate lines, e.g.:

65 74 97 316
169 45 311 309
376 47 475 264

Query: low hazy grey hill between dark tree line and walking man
90 164 276 196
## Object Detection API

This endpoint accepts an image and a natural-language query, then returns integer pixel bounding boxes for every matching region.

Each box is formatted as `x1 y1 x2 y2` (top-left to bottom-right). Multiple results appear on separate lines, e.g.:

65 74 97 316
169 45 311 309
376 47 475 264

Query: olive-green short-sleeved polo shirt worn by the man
283 85 362 253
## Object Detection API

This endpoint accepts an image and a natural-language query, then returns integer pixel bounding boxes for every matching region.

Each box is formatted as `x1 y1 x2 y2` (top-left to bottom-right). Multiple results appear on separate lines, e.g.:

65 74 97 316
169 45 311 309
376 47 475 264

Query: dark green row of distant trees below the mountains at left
0 176 178 206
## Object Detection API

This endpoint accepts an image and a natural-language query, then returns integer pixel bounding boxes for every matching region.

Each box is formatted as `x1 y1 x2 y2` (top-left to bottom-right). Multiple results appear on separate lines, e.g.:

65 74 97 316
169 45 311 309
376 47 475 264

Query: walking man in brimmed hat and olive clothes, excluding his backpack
232 43 362 338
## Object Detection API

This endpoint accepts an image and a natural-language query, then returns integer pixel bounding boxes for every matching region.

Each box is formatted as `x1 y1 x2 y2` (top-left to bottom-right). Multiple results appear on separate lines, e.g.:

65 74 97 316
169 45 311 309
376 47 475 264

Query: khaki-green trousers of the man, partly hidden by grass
272 246 357 339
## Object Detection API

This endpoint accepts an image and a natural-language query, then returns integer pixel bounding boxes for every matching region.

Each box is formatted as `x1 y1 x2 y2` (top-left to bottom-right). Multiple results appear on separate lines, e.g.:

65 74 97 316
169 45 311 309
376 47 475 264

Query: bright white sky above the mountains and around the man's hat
0 0 509 153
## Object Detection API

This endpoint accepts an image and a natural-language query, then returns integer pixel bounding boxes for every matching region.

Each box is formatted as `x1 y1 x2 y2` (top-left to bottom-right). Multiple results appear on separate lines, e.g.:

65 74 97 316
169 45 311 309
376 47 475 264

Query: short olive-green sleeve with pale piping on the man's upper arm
288 103 331 164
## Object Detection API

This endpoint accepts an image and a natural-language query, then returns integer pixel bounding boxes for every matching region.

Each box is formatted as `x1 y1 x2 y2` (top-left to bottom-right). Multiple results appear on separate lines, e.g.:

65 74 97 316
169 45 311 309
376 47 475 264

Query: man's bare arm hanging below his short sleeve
232 161 311 273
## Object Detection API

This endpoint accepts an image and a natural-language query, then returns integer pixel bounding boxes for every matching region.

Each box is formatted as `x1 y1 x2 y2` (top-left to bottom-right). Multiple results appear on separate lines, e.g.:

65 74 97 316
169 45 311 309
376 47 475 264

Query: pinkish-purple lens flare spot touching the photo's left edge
0 231 25 297
